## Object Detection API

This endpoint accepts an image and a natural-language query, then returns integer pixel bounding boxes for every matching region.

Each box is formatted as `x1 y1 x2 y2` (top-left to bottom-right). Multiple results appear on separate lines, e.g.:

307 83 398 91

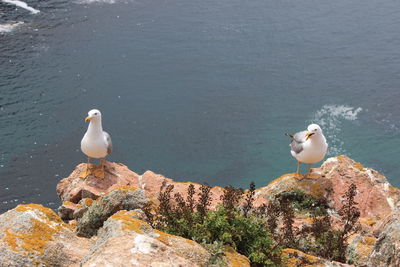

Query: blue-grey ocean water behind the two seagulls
0 0 400 212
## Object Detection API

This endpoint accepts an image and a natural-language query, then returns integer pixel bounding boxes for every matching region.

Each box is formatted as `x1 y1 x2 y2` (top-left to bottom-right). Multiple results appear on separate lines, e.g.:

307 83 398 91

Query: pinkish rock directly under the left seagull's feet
57 162 139 203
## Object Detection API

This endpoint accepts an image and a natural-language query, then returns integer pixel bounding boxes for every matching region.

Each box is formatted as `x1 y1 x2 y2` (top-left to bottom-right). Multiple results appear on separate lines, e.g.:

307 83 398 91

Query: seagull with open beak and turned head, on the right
285 124 328 178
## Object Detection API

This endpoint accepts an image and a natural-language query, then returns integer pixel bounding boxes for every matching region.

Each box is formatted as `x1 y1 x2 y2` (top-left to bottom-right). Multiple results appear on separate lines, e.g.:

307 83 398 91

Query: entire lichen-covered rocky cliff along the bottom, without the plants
0 156 400 266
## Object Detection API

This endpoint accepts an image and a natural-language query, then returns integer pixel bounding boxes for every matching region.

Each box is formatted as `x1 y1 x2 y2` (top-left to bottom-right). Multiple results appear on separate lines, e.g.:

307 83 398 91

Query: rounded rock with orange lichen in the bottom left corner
0 204 92 267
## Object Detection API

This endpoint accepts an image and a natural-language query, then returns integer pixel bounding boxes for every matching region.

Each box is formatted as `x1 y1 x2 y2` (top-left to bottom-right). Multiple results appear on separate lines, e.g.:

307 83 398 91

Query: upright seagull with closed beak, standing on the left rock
79 109 112 178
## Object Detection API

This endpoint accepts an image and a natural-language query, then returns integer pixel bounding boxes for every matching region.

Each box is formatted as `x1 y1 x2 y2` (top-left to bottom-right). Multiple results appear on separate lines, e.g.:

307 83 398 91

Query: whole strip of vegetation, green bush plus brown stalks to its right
144 181 360 266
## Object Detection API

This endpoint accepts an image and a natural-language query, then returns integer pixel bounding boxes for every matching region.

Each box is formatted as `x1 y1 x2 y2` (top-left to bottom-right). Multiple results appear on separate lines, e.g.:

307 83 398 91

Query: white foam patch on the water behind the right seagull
309 105 363 156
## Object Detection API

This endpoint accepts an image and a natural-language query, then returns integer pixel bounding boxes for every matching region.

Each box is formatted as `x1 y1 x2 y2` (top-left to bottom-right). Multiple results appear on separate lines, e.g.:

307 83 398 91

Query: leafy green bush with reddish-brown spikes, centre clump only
147 182 281 266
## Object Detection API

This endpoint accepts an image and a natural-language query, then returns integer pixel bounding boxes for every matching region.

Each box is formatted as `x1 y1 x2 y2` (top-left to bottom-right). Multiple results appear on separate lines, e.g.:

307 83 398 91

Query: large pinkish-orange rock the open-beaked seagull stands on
256 156 400 227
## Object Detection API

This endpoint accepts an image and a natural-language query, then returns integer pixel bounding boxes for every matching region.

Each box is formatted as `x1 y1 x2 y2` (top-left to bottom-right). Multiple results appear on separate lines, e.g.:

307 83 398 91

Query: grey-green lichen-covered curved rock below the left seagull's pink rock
77 186 147 237
